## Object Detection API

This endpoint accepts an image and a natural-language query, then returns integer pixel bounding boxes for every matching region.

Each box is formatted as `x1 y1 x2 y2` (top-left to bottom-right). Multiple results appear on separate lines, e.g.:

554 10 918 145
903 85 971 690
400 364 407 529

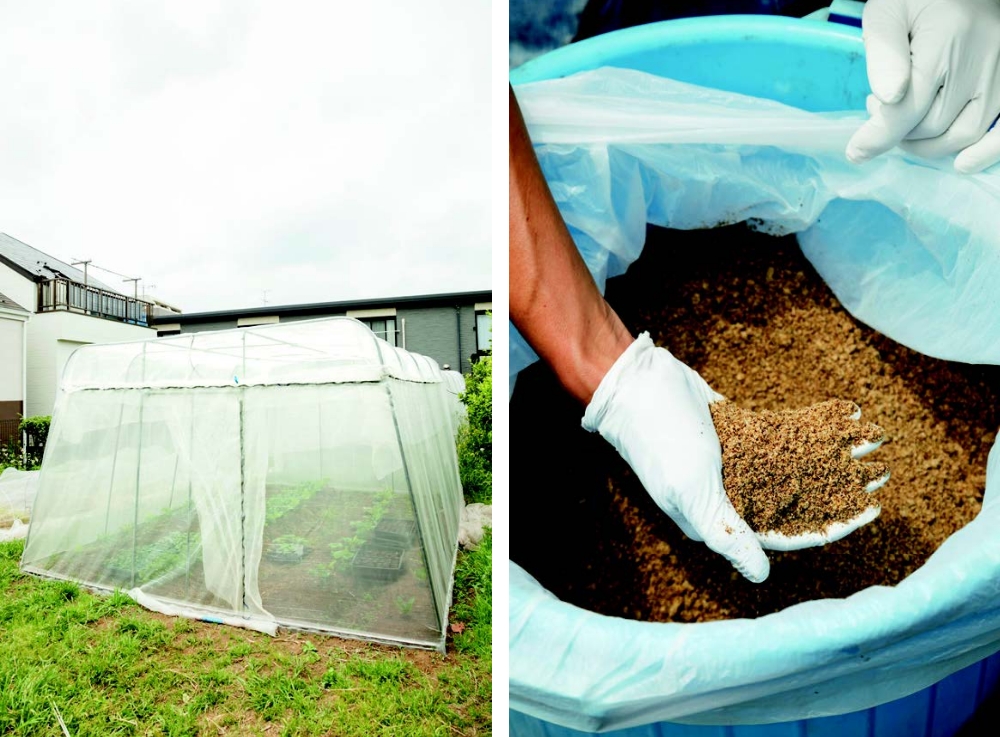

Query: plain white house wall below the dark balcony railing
26 310 156 417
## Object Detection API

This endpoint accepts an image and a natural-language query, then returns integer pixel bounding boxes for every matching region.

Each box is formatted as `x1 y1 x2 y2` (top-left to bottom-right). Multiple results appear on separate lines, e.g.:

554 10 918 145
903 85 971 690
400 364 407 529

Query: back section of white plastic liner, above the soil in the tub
510 68 1000 396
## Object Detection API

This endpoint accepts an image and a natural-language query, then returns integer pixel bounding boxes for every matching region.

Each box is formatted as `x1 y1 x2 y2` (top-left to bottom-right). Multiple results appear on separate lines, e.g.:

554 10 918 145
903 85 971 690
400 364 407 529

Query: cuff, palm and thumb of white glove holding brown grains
583 333 770 583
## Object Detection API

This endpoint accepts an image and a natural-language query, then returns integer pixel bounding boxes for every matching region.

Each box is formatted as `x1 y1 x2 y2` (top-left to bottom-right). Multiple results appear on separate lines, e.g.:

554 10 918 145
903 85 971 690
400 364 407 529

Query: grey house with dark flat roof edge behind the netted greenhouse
152 291 493 374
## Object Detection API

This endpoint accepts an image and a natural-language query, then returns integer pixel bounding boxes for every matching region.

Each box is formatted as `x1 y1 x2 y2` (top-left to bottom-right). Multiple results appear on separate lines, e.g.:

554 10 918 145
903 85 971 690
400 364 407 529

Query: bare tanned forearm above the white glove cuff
509 89 633 404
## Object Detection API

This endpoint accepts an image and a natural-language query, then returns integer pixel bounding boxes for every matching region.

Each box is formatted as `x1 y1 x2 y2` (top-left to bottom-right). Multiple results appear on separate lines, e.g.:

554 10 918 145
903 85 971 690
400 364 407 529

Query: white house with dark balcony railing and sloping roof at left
0 233 156 417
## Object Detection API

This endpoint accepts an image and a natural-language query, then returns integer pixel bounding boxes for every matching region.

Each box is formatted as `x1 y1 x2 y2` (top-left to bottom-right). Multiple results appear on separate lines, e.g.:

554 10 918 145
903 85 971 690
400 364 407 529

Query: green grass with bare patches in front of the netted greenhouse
0 531 493 737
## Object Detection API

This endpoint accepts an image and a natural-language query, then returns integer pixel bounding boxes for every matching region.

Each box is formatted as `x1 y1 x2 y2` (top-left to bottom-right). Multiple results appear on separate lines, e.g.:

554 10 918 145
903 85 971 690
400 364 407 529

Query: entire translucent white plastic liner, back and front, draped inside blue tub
509 68 1000 731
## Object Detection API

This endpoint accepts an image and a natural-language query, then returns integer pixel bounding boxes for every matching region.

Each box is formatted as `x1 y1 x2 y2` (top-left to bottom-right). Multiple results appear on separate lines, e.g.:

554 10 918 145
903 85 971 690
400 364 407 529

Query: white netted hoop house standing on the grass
21 318 462 650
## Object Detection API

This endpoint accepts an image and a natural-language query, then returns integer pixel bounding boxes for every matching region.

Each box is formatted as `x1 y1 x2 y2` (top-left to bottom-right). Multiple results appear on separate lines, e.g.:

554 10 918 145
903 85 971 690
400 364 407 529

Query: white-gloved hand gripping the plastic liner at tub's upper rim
847 0 1000 173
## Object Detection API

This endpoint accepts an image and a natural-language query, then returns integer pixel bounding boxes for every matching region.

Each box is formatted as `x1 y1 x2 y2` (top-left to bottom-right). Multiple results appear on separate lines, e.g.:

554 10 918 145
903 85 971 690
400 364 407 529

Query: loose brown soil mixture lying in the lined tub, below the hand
510 226 1000 622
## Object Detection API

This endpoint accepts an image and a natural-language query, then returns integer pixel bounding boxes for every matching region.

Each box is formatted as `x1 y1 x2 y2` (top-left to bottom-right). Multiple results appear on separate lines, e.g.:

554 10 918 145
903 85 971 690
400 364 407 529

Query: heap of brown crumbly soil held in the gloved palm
710 399 889 537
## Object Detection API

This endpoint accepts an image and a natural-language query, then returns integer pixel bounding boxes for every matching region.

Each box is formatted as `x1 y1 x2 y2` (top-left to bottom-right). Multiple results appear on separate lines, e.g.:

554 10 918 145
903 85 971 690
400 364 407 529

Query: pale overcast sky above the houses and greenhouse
0 0 491 312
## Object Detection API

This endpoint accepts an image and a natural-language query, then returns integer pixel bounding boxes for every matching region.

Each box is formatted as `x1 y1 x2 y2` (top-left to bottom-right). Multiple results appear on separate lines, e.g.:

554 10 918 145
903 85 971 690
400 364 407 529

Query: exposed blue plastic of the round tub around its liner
509 16 1000 737
